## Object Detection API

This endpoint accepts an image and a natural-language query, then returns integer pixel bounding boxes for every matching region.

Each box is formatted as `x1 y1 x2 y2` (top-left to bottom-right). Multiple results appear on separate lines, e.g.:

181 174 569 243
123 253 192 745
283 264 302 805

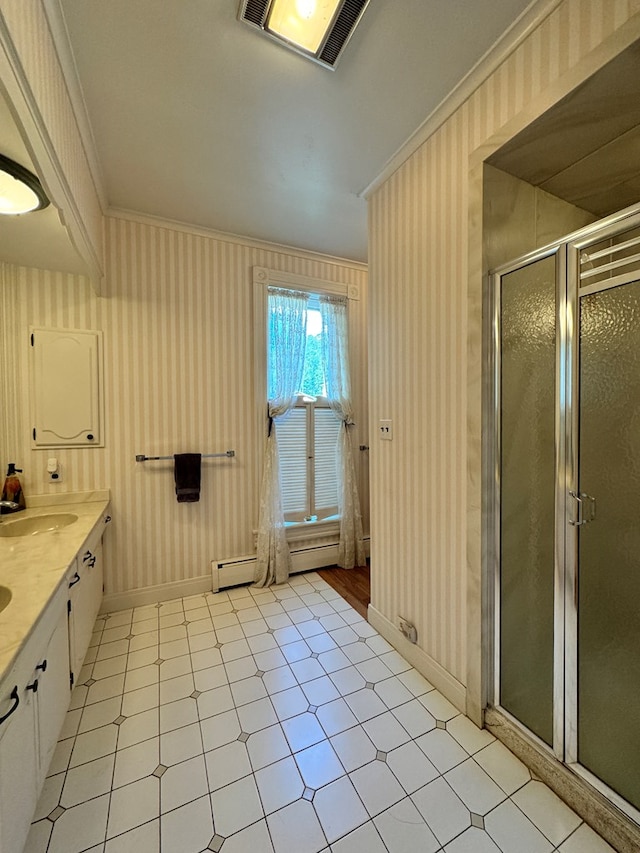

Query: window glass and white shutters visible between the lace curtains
268 294 341 523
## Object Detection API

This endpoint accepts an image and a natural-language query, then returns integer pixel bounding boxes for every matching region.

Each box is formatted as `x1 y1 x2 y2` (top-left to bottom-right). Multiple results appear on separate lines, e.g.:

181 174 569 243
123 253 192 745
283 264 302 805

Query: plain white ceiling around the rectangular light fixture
0 0 530 261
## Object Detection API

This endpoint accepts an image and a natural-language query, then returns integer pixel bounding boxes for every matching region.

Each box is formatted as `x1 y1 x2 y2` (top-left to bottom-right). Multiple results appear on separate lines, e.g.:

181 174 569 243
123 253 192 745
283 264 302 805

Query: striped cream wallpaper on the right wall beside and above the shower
369 0 640 704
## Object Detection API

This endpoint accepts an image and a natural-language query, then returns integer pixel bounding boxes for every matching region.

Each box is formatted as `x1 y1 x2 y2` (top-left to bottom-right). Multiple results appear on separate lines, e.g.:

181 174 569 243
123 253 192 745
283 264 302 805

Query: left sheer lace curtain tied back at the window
255 287 309 586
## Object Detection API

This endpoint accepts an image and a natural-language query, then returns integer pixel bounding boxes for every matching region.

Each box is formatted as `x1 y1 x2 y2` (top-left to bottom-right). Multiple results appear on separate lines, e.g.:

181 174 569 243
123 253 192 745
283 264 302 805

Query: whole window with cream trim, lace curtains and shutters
253 267 366 586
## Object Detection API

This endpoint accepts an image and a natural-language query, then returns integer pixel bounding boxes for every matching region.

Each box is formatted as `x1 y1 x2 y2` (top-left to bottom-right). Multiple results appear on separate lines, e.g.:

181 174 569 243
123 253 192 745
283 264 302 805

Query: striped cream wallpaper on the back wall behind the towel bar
0 216 368 593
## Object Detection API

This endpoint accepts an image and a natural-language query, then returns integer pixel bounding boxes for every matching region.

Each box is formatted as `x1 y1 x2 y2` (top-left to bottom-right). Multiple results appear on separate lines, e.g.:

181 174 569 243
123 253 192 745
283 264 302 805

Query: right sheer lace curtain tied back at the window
320 295 365 569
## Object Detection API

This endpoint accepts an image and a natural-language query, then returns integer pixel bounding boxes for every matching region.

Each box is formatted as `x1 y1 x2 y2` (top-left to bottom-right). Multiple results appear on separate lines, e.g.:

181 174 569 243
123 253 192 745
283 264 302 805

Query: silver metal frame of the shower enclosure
483 205 640 824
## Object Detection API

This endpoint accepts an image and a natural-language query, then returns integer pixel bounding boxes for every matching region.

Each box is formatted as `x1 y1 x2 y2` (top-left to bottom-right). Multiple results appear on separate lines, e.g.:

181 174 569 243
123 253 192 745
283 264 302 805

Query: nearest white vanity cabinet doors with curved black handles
0 589 70 853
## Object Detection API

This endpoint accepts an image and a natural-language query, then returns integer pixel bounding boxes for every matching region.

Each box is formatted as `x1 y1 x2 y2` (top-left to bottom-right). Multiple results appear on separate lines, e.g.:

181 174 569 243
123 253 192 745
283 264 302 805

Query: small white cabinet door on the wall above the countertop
30 328 104 447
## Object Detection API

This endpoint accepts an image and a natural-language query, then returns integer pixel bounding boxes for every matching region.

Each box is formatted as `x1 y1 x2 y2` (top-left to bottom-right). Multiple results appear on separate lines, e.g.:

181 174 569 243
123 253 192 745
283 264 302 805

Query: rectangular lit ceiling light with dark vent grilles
238 0 369 68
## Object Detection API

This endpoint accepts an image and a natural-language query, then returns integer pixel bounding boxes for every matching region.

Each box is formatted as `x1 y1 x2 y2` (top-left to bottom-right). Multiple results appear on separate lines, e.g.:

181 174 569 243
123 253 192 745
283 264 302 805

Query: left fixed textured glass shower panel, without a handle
500 255 556 745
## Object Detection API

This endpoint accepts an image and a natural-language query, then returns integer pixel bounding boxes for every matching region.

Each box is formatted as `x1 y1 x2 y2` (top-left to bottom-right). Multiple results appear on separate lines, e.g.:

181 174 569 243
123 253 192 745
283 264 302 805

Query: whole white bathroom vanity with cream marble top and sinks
0 492 110 853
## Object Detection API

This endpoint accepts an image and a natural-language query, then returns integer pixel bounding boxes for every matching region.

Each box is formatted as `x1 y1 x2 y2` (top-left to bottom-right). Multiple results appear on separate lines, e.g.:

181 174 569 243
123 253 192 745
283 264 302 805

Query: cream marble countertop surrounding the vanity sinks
0 491 109 681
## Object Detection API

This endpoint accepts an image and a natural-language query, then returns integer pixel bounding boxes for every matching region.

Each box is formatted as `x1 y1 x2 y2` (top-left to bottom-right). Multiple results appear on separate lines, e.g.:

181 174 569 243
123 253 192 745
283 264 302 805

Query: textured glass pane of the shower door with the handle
578 282 640 808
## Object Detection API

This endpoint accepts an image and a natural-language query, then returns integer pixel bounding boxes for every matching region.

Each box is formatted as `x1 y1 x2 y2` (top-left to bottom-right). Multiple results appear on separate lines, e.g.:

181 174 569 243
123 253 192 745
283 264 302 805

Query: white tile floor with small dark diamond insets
25 573 611 853
